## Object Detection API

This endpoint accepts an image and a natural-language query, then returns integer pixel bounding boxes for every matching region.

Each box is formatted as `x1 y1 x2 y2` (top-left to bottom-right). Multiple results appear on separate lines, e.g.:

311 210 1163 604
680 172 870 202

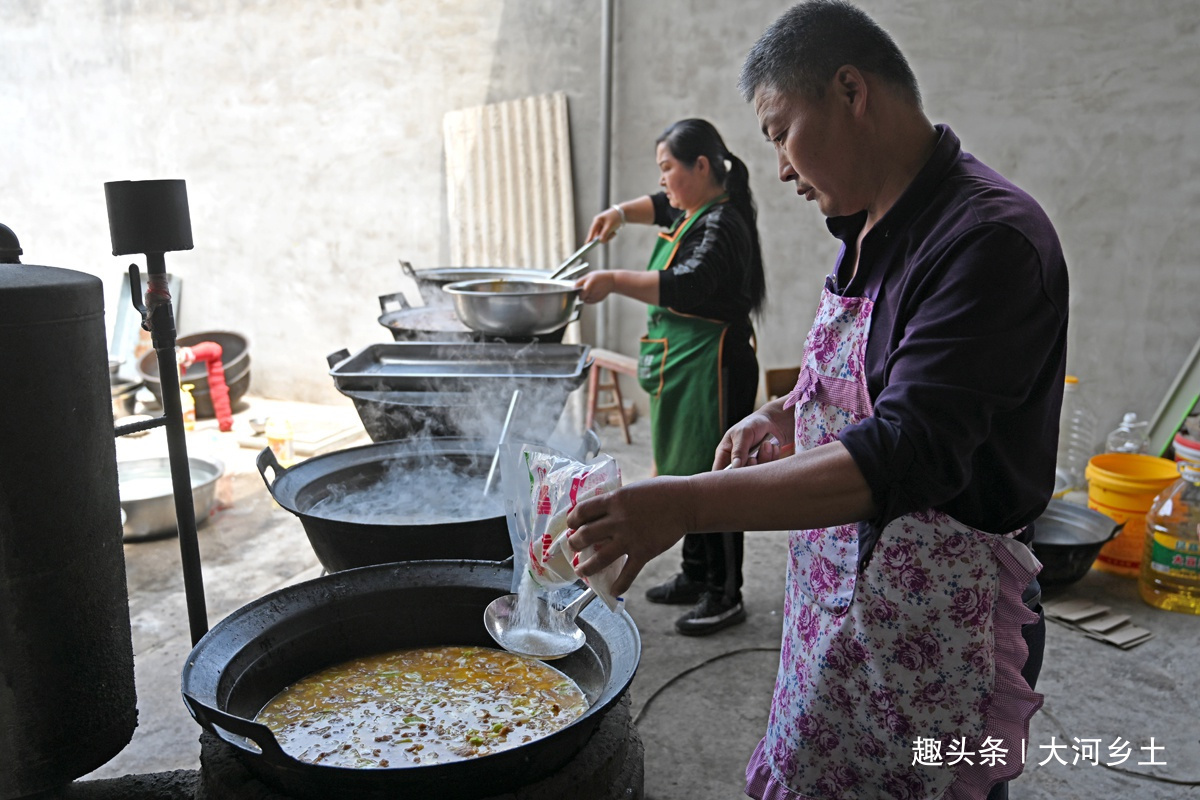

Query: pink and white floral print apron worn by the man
746 289 1042 800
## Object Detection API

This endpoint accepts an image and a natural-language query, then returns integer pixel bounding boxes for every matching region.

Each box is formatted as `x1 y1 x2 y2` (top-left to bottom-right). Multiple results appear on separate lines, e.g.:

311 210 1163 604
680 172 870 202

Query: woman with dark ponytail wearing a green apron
578 119 766 636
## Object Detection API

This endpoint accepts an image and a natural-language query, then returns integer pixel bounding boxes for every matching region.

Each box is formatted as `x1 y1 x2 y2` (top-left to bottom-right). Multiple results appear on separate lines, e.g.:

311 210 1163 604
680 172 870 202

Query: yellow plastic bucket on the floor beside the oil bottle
1084 453 1180 578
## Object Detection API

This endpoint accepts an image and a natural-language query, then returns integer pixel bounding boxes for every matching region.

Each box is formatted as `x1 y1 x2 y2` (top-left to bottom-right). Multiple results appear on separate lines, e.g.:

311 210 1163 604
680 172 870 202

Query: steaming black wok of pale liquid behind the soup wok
256 439 512 572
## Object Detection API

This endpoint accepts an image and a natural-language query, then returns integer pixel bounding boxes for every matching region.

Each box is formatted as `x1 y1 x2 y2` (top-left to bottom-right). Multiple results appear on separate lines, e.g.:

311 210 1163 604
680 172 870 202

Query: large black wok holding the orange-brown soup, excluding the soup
182 561 642 800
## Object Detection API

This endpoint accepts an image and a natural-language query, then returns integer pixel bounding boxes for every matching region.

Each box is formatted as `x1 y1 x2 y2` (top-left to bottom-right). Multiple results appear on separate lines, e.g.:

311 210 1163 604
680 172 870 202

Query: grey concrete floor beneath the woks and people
84 397 1200 800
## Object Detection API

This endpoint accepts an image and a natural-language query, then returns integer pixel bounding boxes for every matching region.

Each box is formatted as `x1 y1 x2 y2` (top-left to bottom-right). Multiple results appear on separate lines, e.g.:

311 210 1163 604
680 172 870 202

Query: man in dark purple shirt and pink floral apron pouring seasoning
568 0 1067 800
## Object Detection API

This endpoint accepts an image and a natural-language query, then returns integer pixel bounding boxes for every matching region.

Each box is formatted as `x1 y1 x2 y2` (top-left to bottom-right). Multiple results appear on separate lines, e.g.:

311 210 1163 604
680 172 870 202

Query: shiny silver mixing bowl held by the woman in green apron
442 279 580 337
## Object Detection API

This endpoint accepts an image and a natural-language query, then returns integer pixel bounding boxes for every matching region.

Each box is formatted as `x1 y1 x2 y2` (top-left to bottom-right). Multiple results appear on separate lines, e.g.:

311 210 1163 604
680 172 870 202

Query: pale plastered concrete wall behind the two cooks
0 0 1200 448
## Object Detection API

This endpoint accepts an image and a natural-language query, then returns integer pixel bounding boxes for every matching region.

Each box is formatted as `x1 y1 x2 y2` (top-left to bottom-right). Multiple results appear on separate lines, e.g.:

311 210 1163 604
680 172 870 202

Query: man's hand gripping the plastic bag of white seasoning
566 476 692 596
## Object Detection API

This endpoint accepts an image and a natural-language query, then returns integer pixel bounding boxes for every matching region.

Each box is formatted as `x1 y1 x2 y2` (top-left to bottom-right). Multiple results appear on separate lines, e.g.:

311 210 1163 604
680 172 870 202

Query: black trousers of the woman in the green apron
683 326 758 600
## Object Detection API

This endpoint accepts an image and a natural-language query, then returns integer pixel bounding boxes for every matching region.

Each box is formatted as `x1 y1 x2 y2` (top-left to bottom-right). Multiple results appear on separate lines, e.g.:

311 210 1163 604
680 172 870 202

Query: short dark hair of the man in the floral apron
738 0 920 107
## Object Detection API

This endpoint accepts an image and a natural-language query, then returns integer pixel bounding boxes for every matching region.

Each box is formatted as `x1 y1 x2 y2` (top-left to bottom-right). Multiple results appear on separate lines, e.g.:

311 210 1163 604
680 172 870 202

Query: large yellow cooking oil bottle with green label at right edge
1139 462 1200 615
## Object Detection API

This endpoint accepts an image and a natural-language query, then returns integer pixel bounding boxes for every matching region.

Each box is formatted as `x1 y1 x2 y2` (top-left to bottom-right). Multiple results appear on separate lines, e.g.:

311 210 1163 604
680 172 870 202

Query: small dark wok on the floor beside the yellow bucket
1033 500 1124 587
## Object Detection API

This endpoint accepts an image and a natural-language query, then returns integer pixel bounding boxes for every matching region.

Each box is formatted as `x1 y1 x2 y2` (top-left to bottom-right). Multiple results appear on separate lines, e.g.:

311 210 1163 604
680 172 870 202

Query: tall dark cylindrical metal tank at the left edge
0 235 137 800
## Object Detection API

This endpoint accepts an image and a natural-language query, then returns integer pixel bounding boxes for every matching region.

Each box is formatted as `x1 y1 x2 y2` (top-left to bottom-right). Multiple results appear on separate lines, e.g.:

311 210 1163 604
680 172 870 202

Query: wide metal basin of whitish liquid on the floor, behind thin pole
116 456 224 540
